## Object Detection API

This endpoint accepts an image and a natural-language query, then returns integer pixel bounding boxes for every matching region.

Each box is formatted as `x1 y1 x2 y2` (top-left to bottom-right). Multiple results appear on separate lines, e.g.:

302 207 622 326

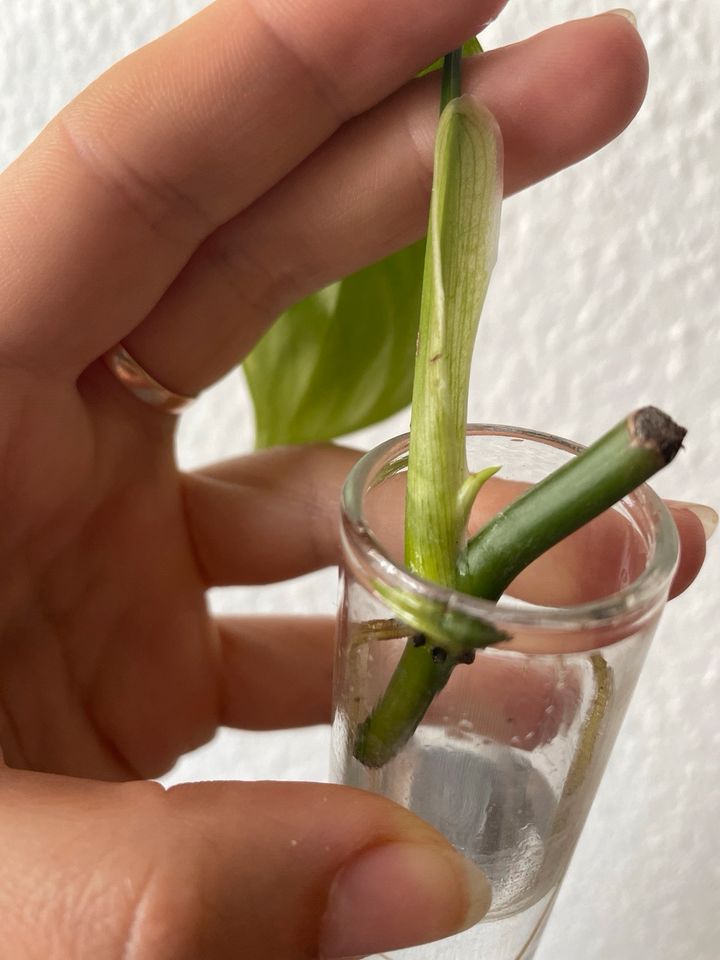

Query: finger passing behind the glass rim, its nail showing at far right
184 444 716 606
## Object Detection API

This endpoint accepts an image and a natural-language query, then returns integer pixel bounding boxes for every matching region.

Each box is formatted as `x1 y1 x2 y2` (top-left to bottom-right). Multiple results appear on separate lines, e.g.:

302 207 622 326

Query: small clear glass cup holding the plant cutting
331 426 678 960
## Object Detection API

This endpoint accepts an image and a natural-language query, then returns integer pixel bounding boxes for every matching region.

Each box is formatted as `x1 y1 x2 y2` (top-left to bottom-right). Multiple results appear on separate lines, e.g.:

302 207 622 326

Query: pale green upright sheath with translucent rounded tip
405 97 502 587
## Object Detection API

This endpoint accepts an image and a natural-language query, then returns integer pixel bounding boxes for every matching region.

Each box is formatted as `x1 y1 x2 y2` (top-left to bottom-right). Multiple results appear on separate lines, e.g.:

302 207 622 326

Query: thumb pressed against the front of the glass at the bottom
0 770 490 960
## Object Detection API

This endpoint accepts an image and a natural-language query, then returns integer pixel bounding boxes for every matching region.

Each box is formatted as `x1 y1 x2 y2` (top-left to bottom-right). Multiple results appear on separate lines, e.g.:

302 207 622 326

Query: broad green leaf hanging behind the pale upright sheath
244 39 481 447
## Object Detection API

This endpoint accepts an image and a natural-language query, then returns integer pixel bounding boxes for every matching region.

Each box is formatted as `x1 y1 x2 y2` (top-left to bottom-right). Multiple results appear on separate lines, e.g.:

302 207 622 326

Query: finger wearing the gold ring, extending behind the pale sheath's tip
122 16 647 393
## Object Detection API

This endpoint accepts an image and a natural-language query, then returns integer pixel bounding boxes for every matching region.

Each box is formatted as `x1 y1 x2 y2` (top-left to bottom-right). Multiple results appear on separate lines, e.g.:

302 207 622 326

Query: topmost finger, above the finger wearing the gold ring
0 0 502 373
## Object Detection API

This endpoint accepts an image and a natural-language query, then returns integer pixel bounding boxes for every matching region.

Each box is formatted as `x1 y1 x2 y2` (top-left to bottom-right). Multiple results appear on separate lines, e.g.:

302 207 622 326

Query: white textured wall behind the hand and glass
0 0 720 960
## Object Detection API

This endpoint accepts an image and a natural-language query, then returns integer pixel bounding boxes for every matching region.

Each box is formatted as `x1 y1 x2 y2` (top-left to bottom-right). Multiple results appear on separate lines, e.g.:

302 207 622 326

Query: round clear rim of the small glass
341 423 679 643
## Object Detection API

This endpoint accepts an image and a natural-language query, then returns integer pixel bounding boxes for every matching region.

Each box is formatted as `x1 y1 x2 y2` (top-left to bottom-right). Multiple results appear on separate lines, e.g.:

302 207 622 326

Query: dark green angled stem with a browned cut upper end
354 407 685 767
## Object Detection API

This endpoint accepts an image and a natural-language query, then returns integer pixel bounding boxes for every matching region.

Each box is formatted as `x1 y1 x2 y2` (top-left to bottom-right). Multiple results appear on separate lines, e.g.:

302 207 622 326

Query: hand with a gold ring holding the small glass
0 0 704 960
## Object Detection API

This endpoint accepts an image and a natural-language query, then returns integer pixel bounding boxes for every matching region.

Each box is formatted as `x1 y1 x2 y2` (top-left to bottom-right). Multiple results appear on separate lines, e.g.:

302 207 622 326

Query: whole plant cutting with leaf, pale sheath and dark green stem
245 39 685 766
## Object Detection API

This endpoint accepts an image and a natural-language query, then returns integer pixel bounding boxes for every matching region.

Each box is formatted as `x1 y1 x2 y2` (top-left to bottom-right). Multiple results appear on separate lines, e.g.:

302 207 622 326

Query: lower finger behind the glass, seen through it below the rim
217 617 579 750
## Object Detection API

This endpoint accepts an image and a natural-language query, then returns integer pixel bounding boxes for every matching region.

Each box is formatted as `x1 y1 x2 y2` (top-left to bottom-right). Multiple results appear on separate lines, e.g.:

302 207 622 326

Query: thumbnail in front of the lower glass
320 842 490 960
